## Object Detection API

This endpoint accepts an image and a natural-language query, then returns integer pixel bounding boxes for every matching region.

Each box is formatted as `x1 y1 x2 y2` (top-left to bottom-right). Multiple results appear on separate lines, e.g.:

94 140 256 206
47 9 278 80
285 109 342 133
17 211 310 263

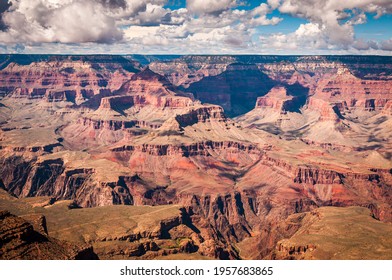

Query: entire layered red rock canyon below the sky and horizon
0 54 392 260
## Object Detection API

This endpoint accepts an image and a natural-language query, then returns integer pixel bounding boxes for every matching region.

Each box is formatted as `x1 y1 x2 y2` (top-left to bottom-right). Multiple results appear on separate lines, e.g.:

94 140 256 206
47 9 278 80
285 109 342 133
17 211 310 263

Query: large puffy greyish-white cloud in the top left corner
0 0 122 43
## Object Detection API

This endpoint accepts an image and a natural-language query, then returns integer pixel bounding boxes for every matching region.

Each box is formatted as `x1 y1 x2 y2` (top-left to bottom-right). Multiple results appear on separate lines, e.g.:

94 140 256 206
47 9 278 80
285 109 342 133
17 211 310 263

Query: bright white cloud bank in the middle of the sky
124 3 281 53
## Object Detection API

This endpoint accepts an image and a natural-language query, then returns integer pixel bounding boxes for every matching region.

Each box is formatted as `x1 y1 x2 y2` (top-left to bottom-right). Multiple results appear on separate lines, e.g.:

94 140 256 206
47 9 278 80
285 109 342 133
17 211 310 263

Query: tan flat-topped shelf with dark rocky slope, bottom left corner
0 190 210 259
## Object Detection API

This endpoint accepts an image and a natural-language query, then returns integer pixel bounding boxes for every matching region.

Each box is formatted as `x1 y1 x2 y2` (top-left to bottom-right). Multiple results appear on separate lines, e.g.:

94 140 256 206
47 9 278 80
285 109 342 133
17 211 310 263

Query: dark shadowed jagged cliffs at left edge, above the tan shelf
0 158 133 207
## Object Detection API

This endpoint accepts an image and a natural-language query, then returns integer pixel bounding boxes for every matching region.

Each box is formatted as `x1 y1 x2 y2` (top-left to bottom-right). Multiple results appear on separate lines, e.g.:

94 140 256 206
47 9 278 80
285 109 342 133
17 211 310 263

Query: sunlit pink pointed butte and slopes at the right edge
237 68 392 157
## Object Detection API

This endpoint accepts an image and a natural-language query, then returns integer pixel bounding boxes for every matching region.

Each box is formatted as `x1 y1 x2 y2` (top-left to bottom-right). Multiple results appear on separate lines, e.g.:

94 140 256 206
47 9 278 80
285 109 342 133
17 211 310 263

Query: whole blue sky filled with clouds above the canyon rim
0 0 392 55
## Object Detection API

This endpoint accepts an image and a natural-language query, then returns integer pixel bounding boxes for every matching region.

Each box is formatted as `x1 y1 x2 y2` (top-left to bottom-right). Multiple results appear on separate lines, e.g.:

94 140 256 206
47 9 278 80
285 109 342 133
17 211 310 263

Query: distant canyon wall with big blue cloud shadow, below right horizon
151 56 391 116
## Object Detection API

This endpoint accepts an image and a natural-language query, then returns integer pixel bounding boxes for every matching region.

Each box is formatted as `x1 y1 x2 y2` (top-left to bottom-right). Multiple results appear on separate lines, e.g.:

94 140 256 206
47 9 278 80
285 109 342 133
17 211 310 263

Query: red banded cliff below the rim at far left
0 57 136 103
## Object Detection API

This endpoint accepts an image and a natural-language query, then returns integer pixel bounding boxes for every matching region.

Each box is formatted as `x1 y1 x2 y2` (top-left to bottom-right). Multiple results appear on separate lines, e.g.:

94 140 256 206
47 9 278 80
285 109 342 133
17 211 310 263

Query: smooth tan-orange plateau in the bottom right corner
270 207 392 260
